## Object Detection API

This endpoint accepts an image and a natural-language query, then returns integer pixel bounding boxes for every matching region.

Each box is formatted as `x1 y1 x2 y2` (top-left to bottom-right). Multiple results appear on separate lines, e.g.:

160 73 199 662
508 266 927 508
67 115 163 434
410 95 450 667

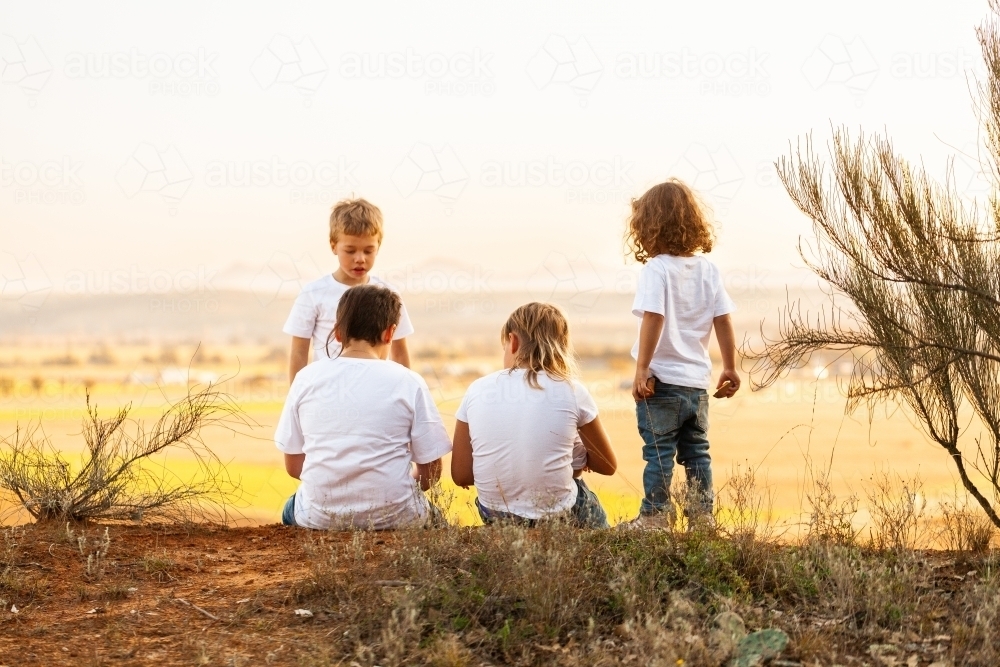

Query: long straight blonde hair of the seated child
500 301 577 389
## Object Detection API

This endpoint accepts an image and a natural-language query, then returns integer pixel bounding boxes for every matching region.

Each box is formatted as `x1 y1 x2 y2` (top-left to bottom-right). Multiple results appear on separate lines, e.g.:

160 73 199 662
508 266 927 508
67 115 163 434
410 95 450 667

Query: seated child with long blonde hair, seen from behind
451 303 617 528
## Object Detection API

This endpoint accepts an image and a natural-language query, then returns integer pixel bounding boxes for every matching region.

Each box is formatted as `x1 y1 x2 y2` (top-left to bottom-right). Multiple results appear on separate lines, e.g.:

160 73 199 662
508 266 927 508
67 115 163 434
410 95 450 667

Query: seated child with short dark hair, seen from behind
274 285 451 530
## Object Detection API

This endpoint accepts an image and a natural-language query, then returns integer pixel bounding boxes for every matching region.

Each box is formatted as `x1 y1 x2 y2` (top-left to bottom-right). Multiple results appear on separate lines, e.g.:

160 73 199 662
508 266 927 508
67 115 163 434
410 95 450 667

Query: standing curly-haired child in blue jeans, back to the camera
626 179 740 526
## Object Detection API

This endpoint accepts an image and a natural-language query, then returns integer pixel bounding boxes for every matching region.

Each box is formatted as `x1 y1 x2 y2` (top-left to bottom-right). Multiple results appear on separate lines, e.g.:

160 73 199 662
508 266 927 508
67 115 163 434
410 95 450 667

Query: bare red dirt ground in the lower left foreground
0 525 350 667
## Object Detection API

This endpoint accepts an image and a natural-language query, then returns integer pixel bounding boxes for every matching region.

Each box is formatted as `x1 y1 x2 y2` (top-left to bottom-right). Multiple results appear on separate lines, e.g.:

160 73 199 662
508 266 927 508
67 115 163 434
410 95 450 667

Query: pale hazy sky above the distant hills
0 0 988 300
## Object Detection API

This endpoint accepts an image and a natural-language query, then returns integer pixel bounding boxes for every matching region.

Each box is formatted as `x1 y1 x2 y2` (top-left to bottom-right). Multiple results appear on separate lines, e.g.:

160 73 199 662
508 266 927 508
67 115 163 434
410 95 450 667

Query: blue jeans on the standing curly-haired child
635 380 713 515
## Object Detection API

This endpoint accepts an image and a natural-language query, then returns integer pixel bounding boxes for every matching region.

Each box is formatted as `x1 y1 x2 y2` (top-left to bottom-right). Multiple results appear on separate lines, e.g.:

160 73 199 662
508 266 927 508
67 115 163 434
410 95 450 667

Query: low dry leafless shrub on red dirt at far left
0 385 248 521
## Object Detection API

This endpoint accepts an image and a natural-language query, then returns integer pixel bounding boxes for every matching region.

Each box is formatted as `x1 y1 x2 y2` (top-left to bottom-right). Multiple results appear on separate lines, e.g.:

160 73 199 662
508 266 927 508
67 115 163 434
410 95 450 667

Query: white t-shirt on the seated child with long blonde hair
455 369 597 519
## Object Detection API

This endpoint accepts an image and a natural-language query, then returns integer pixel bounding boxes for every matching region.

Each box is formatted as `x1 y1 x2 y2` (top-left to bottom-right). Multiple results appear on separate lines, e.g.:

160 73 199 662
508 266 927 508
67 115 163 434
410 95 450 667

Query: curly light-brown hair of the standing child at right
625 178 715 264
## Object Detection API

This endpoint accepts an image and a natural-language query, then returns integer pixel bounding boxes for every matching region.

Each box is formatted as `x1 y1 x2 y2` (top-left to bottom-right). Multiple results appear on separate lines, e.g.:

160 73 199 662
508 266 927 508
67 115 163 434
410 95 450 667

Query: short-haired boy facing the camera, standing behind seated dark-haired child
282 199 413 382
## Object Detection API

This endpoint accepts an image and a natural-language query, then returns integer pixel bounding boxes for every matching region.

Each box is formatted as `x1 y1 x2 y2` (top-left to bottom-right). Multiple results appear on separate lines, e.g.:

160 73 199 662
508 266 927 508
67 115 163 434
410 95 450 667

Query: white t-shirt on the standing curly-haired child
632 255 736 389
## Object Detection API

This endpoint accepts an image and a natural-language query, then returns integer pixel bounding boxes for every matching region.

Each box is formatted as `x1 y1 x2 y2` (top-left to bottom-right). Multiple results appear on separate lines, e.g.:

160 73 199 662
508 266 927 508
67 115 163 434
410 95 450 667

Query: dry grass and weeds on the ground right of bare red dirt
282 471 1000 665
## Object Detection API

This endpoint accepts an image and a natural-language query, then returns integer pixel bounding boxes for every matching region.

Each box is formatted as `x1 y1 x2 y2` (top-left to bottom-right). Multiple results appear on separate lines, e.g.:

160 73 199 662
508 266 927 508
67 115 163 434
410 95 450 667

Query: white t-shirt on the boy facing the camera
282 273 413 361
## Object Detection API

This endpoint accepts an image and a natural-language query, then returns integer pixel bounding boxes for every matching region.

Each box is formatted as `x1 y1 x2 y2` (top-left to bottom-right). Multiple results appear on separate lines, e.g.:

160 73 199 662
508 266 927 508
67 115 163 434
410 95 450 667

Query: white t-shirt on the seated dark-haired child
274 357 451 529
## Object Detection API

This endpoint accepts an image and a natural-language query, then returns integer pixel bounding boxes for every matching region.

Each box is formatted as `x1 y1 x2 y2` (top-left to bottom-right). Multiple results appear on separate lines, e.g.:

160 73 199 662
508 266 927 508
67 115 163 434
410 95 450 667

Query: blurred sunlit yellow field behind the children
0 346 971 523
